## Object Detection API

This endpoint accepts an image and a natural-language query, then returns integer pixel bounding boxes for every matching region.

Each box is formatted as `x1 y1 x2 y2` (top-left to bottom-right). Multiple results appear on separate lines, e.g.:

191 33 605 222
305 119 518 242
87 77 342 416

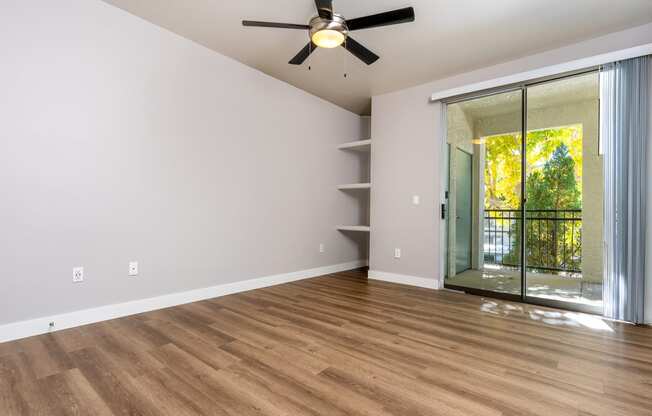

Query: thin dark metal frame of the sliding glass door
441 66 603 315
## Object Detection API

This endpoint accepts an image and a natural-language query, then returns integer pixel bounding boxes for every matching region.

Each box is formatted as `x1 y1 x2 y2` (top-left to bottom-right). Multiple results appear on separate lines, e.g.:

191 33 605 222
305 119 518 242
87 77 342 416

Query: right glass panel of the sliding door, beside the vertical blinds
526 73 603 307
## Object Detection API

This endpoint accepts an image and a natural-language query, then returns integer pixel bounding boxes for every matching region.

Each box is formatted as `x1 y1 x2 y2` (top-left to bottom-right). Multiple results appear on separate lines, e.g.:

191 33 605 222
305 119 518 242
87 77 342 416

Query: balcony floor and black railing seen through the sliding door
447 209 602 307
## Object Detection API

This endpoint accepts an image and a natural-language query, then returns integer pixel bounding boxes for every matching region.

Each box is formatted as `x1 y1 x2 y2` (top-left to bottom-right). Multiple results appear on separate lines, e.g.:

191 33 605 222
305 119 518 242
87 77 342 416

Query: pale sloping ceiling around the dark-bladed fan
104 0 652 114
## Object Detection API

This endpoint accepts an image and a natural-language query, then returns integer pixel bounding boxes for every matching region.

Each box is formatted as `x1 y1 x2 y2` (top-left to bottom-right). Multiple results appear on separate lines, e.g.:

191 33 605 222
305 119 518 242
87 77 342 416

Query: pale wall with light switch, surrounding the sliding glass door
370 24 652 316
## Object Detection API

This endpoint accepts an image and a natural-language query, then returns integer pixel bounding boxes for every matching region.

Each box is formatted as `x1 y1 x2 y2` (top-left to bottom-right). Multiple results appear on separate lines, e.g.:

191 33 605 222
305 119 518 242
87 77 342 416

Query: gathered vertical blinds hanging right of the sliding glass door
600 56 650 323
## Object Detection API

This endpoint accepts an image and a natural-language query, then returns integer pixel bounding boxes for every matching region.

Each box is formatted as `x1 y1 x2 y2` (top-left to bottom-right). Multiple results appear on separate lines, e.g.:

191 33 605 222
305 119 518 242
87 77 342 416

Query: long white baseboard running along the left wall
0 260 368 342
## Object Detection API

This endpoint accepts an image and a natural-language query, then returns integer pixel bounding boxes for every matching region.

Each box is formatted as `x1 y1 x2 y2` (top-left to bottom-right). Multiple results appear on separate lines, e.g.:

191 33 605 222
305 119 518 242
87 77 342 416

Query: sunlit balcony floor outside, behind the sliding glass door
446 265 602 307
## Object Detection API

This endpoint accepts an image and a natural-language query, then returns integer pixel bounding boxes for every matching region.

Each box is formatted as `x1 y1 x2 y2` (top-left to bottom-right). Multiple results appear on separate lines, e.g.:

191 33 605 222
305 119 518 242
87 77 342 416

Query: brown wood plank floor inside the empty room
0 271 652 416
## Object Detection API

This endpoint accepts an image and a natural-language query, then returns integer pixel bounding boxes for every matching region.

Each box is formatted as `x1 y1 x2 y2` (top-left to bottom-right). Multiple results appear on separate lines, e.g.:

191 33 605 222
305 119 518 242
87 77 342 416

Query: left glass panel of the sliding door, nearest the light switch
445 91 522 296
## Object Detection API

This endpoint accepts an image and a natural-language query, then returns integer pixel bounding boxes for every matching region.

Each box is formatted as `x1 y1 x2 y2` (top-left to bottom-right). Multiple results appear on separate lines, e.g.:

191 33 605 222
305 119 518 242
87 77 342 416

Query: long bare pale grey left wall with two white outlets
0 0 361 324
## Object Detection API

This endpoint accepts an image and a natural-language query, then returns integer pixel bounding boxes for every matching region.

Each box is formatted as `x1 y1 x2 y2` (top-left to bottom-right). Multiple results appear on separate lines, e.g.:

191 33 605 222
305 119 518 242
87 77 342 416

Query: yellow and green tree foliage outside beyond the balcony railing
482 129 582 269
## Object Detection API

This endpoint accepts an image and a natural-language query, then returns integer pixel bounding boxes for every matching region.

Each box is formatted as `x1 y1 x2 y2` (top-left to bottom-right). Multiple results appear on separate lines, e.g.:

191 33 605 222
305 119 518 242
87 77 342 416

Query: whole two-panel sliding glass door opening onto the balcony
445 72 602 312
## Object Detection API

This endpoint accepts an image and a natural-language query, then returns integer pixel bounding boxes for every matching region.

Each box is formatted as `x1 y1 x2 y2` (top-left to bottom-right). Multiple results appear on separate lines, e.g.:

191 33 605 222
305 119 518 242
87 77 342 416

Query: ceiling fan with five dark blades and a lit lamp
242 0 414 65
